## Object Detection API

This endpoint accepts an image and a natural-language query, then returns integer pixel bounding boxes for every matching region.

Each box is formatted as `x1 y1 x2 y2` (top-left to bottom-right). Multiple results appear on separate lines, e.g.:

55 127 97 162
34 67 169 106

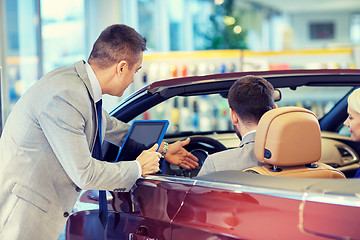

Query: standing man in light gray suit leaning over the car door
0 25 197 240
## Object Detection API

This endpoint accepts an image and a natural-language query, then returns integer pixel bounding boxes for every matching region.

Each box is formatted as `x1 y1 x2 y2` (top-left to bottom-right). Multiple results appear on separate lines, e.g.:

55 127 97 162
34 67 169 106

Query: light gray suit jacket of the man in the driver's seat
197 132 263 176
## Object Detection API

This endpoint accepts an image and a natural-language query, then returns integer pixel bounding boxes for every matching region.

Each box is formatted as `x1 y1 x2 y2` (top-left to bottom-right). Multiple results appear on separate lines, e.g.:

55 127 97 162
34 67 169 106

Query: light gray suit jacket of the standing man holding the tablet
0 61 139 240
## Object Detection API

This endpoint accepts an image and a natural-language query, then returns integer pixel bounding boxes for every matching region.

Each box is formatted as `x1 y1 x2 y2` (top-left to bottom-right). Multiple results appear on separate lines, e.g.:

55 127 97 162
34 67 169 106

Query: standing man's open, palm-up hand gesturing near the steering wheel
165 138 199 169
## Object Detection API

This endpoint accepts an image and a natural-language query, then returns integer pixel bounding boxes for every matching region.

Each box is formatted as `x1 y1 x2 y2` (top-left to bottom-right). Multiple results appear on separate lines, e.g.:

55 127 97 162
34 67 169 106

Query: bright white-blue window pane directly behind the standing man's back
41 0 86 74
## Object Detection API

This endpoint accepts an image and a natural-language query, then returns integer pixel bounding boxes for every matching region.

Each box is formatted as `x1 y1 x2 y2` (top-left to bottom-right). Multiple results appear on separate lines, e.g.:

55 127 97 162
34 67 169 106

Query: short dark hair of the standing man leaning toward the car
88 24 146 69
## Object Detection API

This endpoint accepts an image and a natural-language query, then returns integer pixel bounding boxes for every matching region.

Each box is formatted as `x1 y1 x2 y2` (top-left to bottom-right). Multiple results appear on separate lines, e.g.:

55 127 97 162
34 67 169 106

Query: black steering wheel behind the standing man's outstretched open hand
162 136 227 177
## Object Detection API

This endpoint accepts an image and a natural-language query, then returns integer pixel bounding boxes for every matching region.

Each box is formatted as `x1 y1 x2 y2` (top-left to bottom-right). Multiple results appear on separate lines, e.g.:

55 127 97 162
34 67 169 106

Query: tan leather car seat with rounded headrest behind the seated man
244 107 345 178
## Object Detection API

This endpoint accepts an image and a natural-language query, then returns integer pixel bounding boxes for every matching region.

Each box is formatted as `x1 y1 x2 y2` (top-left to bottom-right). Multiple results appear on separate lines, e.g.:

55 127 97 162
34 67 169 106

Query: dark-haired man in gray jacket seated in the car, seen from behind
198 76 276 176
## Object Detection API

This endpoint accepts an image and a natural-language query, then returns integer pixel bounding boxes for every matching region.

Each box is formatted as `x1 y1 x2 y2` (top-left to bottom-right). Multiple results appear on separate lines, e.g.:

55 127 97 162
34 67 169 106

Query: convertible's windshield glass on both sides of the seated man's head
129 86 352 134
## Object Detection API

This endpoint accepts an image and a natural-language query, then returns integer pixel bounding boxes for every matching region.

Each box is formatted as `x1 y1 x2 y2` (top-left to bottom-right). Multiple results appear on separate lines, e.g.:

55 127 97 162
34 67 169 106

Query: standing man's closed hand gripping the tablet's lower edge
136 144 161 176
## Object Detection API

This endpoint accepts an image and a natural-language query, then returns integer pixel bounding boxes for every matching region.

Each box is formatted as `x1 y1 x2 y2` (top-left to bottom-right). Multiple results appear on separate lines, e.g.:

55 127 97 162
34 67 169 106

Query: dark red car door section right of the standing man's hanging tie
106 177 192 240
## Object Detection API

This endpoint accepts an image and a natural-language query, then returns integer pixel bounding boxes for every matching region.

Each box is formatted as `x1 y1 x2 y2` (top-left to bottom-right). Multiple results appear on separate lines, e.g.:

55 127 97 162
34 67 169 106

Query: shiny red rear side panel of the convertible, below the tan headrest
172 181 318 240
